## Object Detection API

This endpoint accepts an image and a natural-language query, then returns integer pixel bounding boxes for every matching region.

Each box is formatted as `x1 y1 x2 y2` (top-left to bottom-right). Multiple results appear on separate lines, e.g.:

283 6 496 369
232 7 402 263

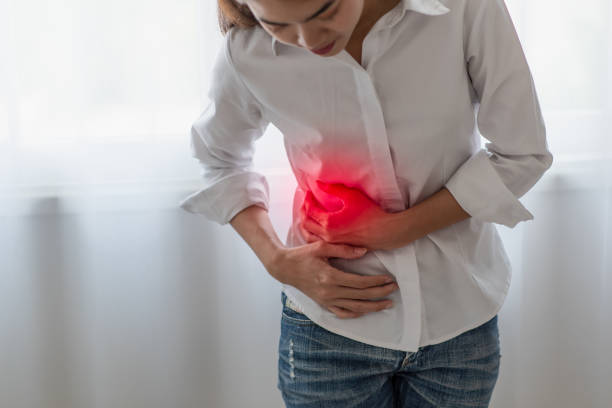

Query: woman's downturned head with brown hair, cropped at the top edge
219 0 364 56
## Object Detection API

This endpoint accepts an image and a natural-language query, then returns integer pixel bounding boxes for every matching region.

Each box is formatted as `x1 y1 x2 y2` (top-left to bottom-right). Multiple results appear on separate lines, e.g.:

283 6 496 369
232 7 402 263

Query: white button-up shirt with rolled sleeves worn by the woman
180 0 553 352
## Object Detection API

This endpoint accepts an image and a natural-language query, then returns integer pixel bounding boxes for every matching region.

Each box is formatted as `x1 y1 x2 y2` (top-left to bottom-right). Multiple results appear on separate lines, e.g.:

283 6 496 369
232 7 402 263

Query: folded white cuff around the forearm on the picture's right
444 149 533 228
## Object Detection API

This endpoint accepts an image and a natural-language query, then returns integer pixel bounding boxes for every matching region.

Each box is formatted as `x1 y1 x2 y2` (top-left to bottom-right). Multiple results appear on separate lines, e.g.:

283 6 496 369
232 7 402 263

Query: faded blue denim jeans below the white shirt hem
277 291 501 408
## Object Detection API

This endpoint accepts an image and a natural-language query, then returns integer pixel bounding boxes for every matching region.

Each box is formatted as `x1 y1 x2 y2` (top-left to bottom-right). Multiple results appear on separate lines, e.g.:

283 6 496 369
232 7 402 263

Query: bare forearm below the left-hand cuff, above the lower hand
230 205 285 271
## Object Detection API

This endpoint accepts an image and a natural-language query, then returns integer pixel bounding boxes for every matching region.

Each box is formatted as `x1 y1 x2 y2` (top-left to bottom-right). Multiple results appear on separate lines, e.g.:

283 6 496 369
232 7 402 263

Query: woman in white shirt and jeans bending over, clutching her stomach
181 0 552 407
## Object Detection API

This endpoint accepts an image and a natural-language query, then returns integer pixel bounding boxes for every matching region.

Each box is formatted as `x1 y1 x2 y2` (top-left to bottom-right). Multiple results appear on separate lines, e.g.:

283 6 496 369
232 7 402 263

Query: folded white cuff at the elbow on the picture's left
179 172 270 225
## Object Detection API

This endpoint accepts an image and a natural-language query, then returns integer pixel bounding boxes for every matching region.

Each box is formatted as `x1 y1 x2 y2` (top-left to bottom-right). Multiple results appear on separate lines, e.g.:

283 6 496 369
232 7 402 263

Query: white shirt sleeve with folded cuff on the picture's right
445 0 553 228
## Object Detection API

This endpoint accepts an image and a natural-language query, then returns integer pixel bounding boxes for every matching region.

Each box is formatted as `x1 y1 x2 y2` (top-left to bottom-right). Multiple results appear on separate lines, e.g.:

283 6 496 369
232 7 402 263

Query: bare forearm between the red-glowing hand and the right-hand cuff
393 187 471 247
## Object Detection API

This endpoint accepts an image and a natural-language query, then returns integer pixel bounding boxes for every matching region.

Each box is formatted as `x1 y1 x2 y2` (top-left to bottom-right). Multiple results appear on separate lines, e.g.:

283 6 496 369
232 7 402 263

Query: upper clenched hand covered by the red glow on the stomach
300 181 397 250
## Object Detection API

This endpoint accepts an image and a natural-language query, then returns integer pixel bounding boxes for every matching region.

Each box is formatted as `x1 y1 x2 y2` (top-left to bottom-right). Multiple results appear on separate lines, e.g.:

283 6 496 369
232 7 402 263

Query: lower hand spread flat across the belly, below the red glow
266 241 398 318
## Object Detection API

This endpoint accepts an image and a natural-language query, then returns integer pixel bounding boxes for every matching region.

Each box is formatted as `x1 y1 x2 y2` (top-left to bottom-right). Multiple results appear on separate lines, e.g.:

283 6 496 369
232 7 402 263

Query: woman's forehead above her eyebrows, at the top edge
244 0 330 23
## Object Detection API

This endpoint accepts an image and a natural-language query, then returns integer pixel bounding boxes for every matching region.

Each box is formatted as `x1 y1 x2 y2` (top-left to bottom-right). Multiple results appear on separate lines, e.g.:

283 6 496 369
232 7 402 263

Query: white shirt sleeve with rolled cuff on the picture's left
180 31 269 225
